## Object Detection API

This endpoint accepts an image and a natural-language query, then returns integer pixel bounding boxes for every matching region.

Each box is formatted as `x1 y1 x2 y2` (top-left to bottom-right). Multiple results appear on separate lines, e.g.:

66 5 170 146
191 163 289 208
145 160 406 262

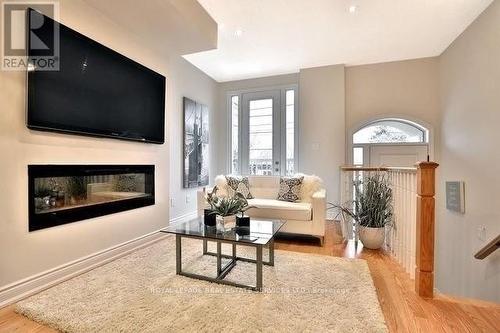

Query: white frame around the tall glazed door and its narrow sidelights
226 84 300 175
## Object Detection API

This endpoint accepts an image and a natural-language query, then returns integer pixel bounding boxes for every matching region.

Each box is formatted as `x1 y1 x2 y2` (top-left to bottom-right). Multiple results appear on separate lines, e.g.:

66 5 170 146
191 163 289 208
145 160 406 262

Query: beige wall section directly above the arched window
345 57 441 159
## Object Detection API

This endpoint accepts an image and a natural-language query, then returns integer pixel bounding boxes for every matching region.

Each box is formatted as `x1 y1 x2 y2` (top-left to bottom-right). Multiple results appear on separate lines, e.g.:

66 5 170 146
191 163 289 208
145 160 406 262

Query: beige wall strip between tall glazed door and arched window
299 65 345 202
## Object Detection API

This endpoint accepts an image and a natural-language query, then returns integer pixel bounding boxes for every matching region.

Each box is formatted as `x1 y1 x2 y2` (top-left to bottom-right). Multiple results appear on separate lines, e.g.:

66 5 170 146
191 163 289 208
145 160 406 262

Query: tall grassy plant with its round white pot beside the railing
333 173 394 249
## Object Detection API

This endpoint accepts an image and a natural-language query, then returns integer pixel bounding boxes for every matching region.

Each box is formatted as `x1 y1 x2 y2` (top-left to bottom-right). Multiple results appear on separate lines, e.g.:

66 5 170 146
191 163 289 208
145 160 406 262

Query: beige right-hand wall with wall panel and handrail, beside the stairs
436 1 500 302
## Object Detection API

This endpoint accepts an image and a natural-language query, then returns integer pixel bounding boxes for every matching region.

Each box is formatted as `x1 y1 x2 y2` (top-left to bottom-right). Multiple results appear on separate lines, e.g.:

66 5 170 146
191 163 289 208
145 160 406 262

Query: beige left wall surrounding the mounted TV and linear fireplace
0 0 215 289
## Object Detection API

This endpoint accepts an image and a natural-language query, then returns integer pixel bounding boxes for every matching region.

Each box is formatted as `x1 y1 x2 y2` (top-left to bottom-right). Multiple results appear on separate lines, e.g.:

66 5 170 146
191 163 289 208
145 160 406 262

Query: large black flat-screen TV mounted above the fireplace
27 10 166 143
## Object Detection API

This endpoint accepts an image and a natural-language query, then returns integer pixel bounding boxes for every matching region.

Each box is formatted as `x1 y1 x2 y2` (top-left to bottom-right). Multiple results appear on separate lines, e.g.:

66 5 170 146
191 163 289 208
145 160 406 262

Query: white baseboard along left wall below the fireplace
0 230 166 308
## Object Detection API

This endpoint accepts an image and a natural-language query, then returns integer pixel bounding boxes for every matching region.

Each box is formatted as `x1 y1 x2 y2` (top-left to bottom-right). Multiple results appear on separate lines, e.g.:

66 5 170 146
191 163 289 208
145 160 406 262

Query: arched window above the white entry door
352 119 428 144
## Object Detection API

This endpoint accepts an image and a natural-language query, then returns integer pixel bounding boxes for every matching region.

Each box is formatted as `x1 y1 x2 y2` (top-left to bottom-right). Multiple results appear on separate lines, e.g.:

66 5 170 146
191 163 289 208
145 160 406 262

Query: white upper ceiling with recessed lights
185 0 492 82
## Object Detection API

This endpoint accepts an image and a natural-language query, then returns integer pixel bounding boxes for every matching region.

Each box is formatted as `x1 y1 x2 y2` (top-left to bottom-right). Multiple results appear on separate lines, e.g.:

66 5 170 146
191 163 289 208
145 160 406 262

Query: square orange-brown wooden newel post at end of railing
415 162 439 298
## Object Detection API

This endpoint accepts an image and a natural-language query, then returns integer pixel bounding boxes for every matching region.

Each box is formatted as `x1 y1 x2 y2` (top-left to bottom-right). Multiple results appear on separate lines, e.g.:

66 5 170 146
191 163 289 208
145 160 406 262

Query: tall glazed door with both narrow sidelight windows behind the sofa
227 86 297 175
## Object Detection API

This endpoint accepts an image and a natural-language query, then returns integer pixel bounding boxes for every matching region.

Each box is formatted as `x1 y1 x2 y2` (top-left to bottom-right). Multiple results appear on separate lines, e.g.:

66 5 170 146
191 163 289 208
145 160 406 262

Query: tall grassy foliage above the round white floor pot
330 173 394 228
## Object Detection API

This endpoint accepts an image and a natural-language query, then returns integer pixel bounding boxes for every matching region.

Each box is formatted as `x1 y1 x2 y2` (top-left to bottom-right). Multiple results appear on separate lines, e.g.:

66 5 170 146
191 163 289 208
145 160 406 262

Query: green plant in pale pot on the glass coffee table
207 192 253 229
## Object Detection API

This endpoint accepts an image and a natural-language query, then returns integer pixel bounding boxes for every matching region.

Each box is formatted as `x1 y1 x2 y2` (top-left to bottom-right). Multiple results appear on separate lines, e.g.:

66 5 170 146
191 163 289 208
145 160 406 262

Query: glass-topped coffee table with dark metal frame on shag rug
161 217 285 291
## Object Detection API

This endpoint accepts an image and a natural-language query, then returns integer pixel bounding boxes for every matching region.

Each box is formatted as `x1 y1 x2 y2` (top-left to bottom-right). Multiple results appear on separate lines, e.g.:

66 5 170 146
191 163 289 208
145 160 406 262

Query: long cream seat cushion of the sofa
246 199 312 221
